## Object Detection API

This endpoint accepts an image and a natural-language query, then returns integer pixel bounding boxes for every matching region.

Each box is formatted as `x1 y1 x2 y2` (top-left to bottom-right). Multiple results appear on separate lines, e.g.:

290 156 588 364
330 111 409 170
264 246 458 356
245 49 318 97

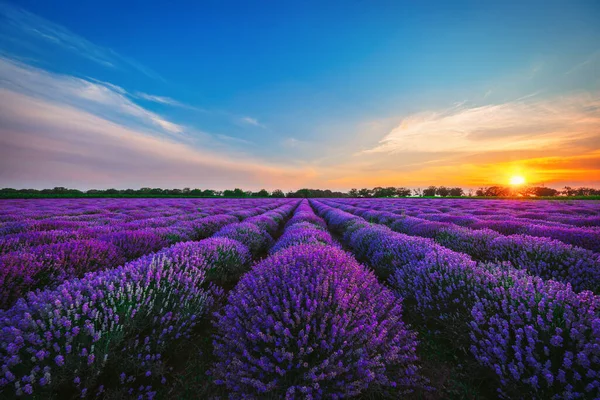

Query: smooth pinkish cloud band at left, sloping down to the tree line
0 88 314 189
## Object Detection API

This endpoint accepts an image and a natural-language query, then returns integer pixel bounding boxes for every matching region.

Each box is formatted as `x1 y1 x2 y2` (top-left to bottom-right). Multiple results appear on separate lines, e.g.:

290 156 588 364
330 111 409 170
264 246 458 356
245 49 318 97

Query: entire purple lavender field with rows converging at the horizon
0 198 600 399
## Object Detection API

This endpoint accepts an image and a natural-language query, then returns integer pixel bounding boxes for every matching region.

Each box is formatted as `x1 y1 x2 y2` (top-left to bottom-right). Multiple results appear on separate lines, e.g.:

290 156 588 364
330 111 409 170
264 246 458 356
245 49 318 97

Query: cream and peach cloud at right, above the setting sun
363 93 600 154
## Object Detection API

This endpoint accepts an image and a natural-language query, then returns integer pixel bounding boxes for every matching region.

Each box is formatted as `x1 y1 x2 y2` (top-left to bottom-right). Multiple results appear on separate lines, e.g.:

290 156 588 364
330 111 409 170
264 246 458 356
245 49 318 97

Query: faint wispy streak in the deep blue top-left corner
0 2 163 80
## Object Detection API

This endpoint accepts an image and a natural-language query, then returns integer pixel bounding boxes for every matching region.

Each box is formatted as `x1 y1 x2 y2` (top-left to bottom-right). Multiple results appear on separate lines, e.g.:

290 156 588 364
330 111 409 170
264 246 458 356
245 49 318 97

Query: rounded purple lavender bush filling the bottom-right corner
470 273 600 399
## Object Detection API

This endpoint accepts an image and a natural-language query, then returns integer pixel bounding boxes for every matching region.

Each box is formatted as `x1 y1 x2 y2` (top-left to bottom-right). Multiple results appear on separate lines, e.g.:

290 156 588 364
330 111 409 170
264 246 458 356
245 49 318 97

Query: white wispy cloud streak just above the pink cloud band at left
0 57 184 135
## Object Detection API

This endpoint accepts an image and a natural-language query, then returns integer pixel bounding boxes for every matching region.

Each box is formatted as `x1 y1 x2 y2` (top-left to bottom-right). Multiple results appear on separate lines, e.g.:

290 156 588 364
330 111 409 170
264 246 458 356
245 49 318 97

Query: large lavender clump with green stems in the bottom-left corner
0 241 221 397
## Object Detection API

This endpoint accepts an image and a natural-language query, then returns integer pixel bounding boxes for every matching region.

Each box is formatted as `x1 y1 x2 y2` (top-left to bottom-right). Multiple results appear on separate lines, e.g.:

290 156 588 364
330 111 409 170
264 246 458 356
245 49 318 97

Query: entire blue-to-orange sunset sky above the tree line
0 0 600 190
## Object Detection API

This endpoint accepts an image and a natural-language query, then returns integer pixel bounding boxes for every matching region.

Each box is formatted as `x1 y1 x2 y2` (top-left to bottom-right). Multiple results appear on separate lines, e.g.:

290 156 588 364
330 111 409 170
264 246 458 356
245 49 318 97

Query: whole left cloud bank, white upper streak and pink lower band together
0 57 314 189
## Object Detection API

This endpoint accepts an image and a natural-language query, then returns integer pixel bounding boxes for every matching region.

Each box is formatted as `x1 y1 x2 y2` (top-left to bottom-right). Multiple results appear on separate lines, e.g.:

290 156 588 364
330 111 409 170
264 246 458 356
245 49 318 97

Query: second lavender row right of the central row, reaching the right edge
324 200 600 293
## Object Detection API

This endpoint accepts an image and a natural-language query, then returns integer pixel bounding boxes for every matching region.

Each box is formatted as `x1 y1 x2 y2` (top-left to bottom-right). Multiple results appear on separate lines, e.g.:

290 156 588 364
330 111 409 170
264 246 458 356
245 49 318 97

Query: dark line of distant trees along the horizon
0 186 600 198
